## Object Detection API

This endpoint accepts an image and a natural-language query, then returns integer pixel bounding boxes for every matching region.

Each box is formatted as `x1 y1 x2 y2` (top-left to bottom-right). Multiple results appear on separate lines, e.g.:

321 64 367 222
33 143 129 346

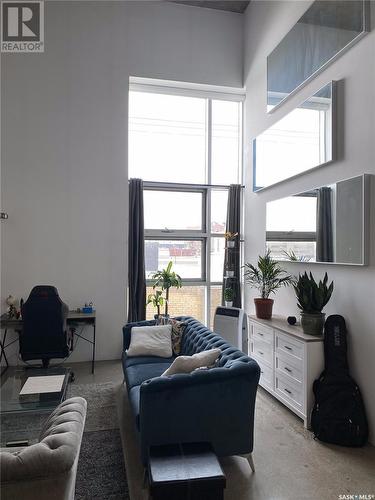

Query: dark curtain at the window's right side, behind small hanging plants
222 184 242 307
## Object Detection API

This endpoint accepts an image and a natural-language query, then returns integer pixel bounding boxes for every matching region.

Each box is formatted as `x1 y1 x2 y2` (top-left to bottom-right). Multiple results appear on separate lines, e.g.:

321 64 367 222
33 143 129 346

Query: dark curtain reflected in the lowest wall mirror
316 187 333 262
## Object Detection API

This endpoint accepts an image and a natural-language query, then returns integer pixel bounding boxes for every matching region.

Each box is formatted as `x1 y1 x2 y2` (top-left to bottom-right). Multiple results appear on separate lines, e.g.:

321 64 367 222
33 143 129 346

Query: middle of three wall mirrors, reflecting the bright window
253 82 336 191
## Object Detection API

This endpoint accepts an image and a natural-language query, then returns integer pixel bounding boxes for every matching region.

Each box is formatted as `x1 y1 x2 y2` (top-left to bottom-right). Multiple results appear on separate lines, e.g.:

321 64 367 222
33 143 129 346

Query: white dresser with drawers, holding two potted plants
248 316 324 428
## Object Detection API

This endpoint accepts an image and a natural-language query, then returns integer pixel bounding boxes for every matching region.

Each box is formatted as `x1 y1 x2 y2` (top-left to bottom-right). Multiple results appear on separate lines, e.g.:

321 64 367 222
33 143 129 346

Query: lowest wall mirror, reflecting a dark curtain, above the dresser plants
266 175 369 265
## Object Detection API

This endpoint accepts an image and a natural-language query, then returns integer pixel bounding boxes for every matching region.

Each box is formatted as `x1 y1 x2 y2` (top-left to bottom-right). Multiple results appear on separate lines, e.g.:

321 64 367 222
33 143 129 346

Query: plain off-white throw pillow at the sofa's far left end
126 325 172 358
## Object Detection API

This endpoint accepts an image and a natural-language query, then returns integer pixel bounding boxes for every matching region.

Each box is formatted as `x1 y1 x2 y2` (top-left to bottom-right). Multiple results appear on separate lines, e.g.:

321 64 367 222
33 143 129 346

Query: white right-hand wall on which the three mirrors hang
244 0 375 442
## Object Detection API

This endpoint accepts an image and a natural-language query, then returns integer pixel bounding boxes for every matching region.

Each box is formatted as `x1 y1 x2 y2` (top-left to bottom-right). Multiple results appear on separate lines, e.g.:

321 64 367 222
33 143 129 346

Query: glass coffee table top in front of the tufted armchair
0 368 71 416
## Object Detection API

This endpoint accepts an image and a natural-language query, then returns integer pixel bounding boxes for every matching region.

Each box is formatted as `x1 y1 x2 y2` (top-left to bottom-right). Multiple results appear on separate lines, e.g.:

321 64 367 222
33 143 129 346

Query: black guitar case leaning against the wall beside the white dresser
311 315 368 446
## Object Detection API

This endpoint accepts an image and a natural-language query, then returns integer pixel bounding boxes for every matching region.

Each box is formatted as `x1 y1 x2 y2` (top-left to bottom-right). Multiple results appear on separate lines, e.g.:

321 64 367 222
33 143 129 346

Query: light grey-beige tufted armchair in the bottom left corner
0 397 87 500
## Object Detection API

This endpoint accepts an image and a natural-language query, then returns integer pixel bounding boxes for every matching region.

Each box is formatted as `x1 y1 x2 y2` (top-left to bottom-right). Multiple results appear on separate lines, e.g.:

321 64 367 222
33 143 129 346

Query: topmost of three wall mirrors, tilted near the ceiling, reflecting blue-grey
267 0 369 111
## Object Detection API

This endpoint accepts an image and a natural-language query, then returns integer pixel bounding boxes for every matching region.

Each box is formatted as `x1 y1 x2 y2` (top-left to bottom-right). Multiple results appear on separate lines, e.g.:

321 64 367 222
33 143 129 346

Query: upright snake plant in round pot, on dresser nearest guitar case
294 272 333 335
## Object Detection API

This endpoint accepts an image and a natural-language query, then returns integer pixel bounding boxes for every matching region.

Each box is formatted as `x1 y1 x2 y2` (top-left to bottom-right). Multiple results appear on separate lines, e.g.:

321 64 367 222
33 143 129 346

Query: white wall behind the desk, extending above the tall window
1 2 243 362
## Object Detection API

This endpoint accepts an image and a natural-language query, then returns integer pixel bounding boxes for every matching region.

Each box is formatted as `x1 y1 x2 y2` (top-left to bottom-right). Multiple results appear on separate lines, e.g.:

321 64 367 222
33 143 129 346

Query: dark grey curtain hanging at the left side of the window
128 179 146 322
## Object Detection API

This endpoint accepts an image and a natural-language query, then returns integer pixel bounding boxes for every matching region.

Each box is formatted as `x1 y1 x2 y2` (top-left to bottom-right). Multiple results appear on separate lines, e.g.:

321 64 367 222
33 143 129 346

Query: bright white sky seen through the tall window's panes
129 92 240 232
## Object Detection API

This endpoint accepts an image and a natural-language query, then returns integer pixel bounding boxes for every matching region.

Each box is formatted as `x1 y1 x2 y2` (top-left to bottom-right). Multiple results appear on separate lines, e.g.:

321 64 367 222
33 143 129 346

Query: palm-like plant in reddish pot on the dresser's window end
244 250 294 319
